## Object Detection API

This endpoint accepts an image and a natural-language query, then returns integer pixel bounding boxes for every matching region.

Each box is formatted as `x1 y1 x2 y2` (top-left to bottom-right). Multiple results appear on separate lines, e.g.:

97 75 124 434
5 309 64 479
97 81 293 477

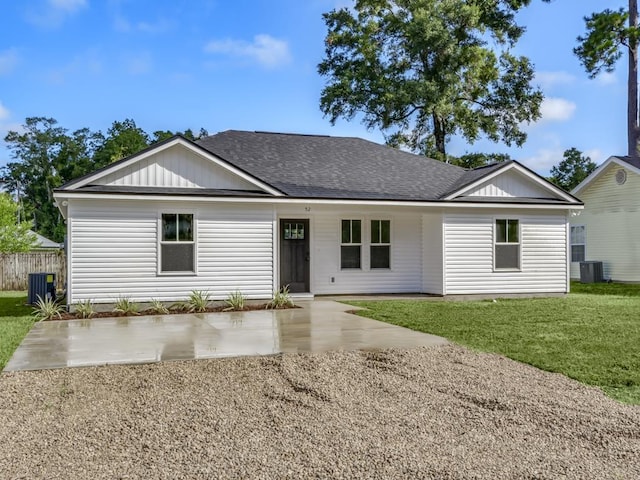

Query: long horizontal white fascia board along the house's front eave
54 191 584 210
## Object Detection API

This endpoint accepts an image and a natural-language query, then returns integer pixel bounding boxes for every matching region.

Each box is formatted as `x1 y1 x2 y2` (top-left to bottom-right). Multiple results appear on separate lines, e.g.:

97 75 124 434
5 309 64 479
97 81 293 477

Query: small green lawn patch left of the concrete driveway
0 292 35 370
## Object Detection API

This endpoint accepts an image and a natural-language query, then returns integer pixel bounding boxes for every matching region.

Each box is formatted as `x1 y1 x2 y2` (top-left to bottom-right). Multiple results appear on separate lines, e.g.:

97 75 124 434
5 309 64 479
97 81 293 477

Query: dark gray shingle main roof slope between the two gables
196 130 470 201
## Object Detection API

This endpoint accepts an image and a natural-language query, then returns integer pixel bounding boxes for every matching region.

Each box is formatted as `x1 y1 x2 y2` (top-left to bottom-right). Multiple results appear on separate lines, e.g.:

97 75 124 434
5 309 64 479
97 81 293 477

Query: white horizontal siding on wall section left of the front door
68 199 273 303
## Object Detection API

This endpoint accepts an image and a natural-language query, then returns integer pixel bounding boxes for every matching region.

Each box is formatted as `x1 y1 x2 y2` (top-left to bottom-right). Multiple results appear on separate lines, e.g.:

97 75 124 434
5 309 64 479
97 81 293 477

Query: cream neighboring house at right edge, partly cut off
571 157 640 282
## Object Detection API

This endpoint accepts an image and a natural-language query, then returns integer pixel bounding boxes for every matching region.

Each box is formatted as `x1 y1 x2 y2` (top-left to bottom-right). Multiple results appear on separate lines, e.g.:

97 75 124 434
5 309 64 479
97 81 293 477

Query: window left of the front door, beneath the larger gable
160 213 195 273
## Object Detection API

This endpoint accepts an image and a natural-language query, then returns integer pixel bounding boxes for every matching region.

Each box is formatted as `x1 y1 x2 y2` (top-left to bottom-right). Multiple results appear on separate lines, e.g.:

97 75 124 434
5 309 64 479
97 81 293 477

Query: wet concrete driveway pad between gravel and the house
4 300 447 371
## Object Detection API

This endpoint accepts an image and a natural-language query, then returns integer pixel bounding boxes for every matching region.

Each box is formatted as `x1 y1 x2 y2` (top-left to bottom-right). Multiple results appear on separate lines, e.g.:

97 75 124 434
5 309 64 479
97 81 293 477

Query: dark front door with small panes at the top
280 219 310 293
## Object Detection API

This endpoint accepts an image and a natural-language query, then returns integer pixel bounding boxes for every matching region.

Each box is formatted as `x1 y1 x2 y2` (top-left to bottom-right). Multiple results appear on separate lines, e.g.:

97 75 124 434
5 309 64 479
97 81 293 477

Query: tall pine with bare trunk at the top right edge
573 0 640 157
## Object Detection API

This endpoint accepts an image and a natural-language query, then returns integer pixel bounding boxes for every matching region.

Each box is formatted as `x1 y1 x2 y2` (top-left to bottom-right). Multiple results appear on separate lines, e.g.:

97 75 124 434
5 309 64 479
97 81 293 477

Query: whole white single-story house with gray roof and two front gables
54 131 582 304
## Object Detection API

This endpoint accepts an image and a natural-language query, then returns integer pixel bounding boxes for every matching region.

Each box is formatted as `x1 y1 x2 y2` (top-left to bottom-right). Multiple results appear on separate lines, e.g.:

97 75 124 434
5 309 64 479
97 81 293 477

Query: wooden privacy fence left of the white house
0 250 67 290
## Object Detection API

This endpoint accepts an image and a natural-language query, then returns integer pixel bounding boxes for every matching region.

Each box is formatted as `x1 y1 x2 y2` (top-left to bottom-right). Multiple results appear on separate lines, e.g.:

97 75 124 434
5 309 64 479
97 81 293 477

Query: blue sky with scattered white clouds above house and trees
0 0 627 175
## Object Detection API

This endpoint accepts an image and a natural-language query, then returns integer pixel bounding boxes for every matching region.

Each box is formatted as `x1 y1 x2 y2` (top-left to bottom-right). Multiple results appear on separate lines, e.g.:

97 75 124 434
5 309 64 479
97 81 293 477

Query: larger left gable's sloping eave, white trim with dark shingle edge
58 135 284 196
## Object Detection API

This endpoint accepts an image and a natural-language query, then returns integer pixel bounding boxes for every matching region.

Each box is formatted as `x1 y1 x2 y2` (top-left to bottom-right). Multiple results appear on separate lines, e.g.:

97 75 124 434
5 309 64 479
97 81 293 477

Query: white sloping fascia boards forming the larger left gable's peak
63 138 283 197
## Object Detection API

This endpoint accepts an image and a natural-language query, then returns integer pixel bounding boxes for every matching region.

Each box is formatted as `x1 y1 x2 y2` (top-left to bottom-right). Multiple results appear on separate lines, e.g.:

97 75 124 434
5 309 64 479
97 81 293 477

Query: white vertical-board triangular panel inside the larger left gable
99 145 257 190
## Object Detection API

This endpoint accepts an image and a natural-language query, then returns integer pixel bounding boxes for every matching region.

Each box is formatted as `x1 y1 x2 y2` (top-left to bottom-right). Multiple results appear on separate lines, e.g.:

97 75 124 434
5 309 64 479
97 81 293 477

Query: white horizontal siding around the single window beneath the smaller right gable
444 211 568 295
